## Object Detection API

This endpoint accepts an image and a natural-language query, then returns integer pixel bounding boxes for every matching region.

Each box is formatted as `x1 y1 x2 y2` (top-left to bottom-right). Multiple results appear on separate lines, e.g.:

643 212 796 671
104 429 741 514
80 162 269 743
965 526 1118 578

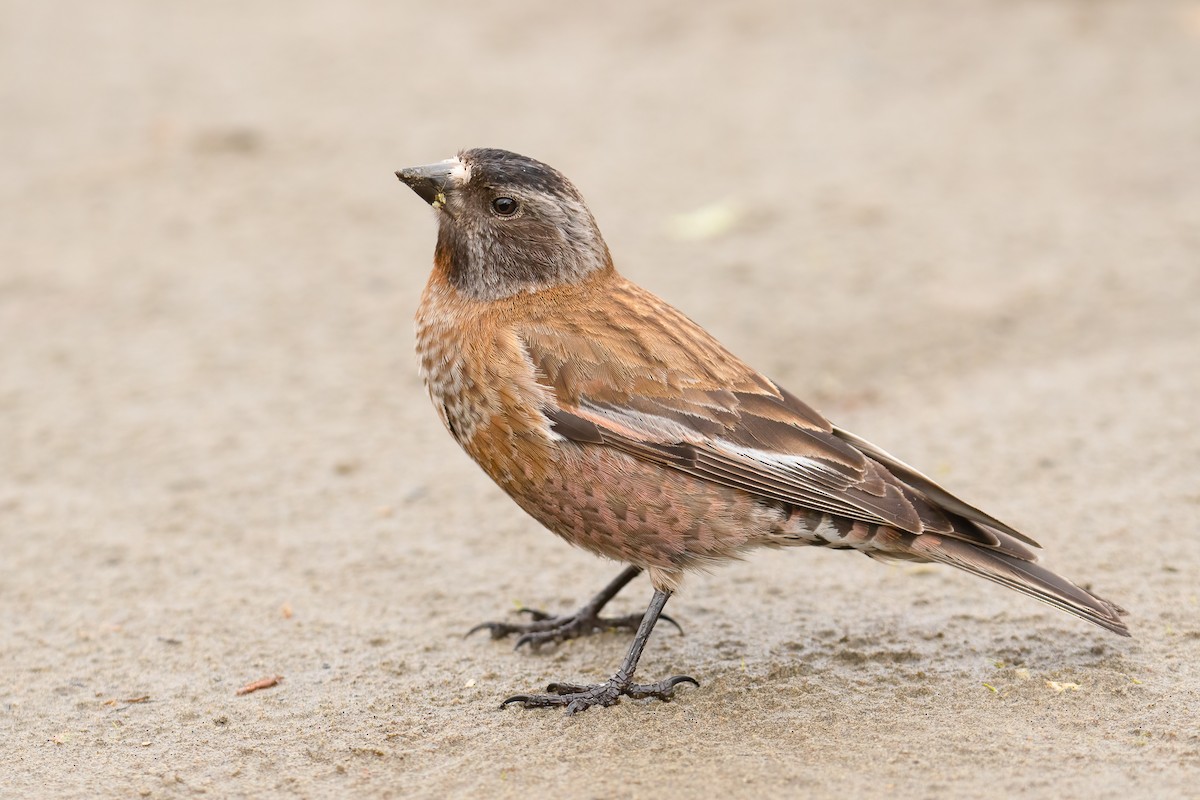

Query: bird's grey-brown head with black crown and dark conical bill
396 149 612 300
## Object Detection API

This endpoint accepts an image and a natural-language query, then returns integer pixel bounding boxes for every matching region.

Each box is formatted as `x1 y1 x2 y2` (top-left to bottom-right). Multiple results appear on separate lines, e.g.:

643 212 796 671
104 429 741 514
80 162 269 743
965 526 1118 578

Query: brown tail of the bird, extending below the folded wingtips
910 534 1129 636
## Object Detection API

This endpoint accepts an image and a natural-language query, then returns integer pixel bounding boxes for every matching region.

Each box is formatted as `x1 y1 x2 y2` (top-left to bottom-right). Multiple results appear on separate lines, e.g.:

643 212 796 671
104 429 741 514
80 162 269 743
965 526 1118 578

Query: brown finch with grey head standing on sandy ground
396 148 1129 714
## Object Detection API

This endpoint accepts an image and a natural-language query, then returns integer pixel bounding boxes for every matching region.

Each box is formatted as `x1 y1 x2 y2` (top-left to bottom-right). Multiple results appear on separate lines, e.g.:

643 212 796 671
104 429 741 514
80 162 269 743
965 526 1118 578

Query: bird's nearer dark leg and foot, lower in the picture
500 589 700 714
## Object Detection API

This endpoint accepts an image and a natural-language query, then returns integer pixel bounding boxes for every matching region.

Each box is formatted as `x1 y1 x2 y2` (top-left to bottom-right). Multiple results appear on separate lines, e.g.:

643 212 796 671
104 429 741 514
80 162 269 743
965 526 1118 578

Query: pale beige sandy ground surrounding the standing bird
0 0 1200 799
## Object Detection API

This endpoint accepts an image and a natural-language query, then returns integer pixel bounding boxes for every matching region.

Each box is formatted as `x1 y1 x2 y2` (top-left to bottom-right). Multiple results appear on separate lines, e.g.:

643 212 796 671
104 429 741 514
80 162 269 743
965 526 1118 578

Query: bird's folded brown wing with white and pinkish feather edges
521 315 1037 560
